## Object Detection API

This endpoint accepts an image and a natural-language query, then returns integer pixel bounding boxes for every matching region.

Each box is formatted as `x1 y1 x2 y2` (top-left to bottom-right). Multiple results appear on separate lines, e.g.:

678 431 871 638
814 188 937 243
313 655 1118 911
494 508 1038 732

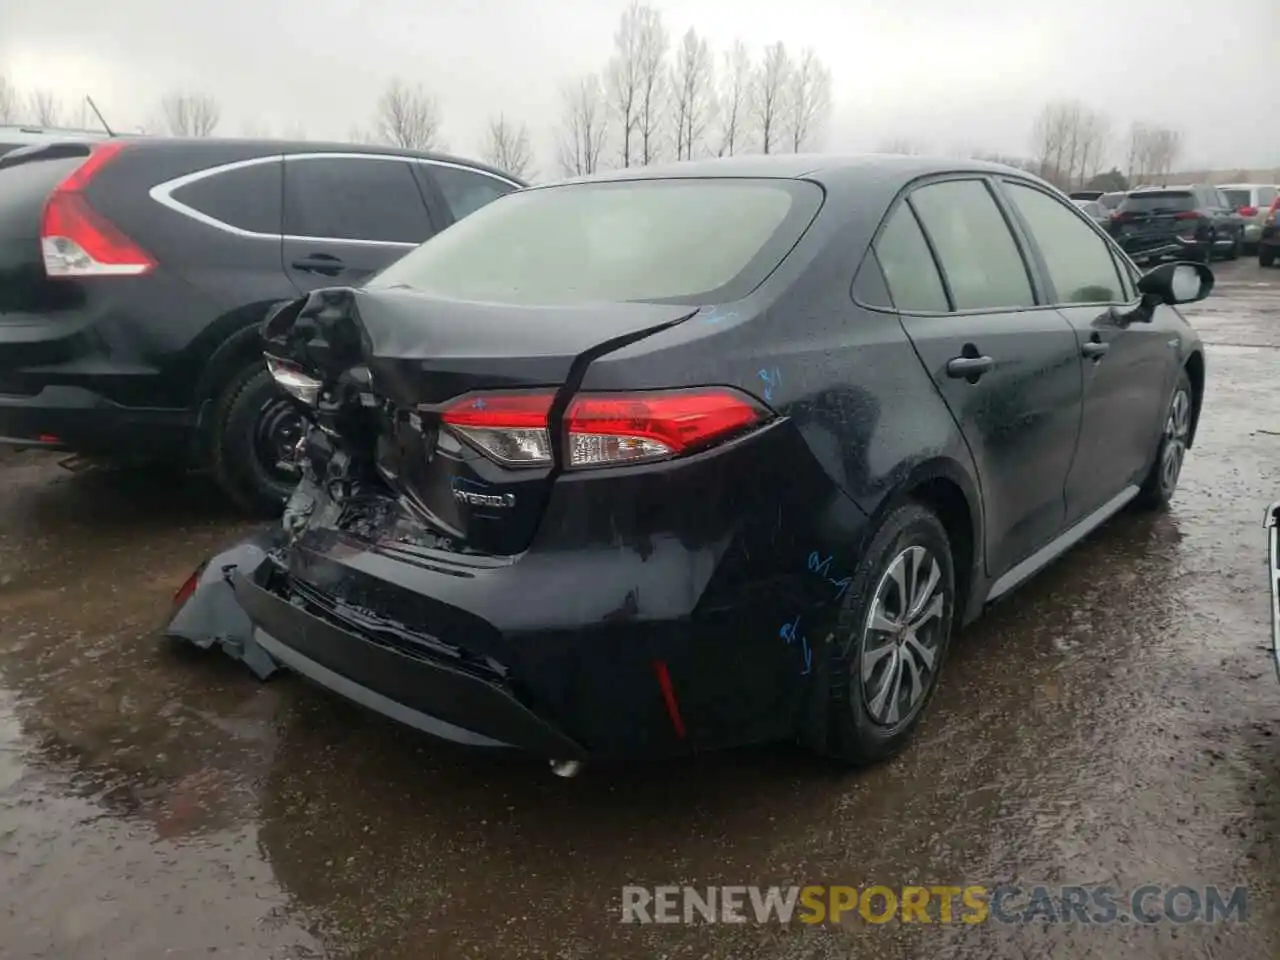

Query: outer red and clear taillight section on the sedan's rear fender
564 388 765 467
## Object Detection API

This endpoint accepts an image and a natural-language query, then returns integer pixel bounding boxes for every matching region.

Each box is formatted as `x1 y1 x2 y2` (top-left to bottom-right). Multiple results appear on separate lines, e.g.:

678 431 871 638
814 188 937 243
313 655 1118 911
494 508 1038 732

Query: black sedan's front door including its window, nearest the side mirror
1001 180 1178 524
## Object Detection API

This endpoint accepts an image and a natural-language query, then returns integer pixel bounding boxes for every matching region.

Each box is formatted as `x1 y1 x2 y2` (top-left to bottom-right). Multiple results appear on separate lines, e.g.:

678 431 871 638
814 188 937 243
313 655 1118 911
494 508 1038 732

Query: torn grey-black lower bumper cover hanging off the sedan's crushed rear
164 531 586 759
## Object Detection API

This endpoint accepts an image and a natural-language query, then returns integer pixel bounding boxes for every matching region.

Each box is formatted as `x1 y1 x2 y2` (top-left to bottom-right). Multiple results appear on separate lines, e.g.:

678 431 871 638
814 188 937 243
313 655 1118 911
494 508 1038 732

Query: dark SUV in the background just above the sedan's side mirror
1110 186 1244 262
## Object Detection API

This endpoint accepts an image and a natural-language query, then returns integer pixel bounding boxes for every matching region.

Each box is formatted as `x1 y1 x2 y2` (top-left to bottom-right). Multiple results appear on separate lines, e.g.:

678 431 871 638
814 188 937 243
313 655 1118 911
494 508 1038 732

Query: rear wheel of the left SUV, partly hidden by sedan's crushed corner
210 360 308 516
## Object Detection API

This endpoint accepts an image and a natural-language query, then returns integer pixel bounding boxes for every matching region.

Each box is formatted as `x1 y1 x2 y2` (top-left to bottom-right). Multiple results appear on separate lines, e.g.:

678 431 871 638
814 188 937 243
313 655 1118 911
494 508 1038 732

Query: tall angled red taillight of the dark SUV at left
40 141 156 278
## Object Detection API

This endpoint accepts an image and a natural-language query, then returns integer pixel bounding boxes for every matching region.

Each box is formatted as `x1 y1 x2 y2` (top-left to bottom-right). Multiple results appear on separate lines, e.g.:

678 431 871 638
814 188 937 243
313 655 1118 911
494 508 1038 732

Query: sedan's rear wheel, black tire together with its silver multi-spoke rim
803 503 956 765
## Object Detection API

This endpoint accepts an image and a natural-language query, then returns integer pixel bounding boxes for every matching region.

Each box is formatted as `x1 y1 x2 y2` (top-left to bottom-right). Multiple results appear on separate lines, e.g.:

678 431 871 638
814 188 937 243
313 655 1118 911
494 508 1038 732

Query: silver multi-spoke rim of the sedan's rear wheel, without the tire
859 545 951 727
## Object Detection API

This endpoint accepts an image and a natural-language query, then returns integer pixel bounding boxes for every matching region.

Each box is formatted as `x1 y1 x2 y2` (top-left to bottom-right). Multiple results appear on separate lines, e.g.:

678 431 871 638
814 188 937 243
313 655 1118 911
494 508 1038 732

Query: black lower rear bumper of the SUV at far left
0 387 196 456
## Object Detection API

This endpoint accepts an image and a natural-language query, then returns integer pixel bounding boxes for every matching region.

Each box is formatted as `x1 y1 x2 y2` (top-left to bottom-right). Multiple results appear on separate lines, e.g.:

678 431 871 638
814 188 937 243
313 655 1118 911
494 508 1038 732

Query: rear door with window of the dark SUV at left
283 154 434 292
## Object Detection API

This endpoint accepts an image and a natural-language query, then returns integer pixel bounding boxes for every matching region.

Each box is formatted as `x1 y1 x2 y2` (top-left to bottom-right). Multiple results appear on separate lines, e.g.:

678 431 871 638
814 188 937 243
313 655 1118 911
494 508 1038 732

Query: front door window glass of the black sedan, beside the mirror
1005 183 1125 303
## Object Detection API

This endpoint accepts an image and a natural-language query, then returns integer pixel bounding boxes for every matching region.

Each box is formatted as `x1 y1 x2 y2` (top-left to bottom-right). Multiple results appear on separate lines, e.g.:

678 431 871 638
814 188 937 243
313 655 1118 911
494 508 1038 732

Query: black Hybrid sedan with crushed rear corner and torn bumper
168 156 1213 764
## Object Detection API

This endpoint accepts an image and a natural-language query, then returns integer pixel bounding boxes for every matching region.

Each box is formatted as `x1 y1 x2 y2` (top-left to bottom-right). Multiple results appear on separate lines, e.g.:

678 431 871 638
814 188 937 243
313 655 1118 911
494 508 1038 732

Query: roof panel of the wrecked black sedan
561 154 1038 190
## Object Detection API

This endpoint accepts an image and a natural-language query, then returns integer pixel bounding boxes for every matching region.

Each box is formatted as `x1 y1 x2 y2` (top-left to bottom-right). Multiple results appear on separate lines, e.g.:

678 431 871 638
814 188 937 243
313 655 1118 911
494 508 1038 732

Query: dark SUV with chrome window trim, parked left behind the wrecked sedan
0 138 524 509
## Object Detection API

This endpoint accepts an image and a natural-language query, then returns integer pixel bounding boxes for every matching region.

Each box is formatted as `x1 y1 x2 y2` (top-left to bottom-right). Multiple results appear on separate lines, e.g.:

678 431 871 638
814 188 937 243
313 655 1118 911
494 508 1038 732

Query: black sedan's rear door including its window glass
876 178 1080 576
